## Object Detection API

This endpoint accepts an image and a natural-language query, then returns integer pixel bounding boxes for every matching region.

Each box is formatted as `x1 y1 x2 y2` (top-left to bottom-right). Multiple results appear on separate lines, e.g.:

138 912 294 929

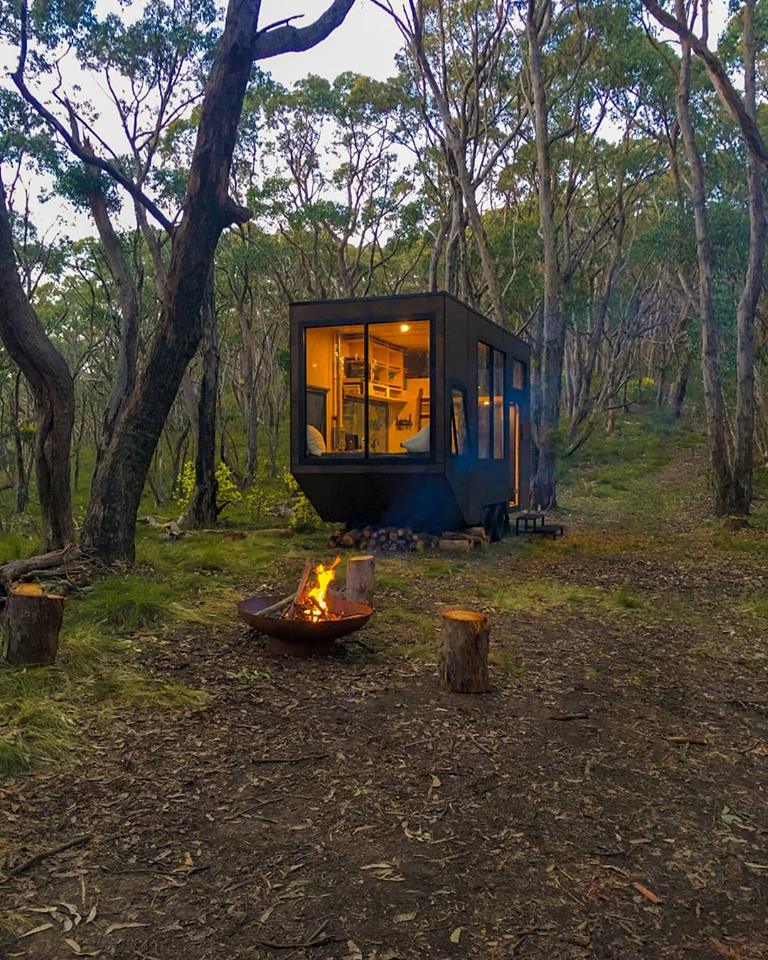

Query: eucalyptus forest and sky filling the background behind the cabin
0 0 768 559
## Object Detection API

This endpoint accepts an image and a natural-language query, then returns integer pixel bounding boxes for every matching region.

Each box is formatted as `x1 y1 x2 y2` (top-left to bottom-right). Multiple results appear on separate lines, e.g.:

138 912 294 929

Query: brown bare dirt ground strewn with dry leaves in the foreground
0 474 768 960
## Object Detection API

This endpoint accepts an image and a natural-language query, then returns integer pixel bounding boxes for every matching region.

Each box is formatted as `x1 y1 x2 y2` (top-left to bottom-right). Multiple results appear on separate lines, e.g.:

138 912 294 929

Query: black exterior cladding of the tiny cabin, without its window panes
290 293 530 530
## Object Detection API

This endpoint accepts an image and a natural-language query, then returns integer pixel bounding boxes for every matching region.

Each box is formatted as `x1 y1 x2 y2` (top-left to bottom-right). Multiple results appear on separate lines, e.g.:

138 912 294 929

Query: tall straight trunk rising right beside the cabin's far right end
527 0 565 510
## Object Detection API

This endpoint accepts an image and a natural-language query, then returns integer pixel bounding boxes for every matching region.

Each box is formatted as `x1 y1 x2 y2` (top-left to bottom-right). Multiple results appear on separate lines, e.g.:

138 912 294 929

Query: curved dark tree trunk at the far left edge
0 183 75 550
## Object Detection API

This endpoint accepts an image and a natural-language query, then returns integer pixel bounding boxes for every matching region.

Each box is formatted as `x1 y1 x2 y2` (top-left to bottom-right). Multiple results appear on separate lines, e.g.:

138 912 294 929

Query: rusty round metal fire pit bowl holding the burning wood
237 597 373 657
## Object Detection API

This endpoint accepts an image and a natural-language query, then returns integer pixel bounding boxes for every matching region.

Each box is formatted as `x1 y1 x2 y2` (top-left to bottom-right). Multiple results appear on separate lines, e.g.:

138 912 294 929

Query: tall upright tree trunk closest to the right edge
727 0 766 513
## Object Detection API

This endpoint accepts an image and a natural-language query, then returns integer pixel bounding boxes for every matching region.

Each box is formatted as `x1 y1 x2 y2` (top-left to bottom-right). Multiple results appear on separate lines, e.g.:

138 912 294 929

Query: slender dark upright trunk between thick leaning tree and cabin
187 270 219 530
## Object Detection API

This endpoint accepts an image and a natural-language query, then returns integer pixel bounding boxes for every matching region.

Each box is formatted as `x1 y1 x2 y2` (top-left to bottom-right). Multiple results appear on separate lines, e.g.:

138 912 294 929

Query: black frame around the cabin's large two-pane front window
298 311 439 468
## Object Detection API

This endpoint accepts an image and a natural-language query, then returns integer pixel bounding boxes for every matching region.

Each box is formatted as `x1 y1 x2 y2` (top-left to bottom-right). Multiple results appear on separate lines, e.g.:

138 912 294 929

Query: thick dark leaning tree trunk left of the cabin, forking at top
81 0 353 559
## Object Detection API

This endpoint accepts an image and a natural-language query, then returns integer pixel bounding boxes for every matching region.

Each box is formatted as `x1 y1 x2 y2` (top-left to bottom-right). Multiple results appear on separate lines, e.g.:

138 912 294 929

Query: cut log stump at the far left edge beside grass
3 583 64 667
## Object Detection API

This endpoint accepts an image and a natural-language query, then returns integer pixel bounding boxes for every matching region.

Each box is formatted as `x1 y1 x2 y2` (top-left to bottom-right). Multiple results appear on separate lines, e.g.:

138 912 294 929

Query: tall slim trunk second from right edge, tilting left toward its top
676 0 731 515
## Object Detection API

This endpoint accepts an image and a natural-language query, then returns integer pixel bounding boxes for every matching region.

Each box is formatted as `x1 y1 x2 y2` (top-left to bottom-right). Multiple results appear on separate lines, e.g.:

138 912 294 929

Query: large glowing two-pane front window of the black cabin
305 320 431 457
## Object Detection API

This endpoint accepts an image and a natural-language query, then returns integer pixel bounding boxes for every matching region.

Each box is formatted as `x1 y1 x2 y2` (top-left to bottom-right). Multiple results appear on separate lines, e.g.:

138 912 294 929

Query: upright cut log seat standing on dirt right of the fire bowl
438 610 490 693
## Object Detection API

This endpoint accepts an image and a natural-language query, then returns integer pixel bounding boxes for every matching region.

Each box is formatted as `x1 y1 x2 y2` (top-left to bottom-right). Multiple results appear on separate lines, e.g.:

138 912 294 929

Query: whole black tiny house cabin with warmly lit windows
290 293 530 539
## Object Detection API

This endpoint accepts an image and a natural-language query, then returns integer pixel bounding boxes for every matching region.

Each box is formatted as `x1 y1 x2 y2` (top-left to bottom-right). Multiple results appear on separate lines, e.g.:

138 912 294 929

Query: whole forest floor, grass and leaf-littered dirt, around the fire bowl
0 412 768 960
